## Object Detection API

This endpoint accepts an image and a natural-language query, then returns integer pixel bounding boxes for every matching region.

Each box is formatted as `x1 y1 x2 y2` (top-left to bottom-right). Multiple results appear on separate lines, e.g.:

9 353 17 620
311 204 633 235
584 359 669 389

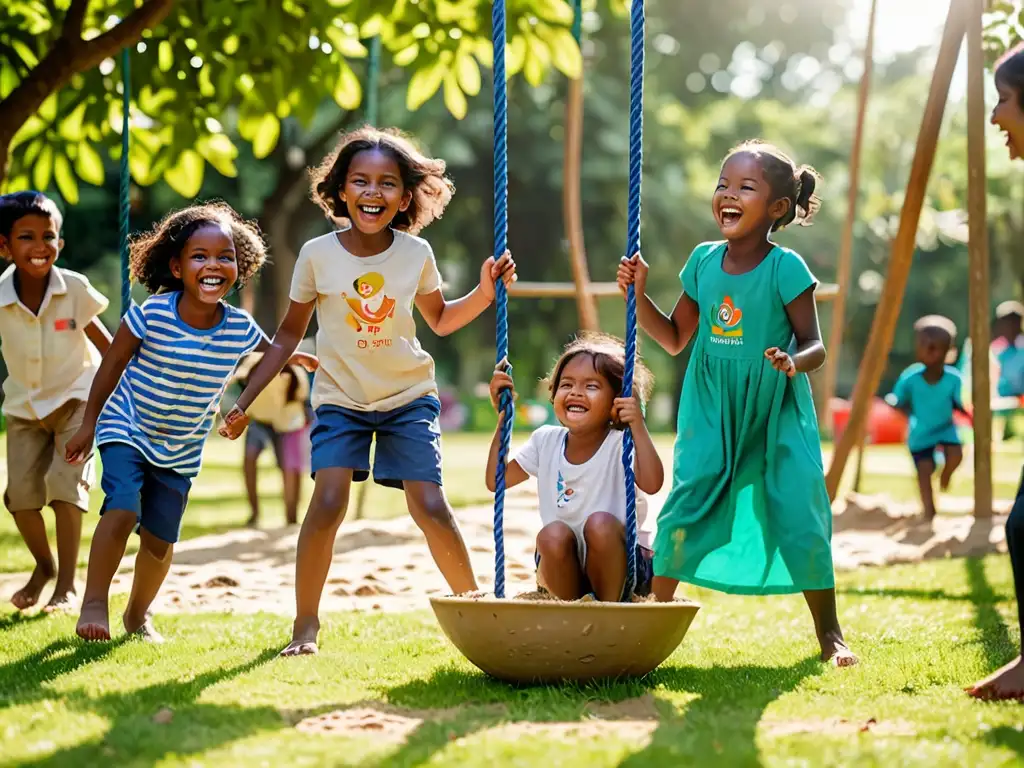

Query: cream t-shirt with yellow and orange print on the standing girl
290 231 441 411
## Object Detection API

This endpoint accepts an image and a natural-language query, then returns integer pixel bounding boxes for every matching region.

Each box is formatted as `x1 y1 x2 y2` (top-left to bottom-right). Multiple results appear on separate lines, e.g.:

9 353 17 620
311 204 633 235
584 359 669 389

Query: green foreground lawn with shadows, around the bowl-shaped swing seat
0 557 1024 768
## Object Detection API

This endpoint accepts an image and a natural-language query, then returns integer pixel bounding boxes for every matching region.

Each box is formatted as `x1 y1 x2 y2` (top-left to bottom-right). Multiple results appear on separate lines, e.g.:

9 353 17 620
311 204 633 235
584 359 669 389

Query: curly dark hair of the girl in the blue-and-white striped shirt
130 202 266 294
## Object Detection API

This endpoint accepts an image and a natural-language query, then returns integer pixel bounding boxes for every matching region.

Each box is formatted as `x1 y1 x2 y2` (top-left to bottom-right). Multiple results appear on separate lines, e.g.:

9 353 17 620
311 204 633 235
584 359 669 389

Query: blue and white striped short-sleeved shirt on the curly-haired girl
96 291 264 477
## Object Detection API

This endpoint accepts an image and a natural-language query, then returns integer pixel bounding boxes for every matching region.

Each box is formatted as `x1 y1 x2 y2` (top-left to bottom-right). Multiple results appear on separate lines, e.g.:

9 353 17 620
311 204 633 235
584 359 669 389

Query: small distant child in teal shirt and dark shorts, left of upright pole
886 314 967 520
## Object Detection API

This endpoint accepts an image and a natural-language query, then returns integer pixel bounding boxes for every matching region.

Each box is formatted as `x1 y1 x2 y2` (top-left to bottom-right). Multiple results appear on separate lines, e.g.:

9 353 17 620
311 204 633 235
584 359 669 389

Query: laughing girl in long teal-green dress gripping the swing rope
618 141 857 667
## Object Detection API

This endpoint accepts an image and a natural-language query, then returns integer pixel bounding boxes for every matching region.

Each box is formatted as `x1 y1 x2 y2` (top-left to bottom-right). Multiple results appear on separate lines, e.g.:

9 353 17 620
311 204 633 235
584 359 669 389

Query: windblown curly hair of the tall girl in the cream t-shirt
309 126 455 234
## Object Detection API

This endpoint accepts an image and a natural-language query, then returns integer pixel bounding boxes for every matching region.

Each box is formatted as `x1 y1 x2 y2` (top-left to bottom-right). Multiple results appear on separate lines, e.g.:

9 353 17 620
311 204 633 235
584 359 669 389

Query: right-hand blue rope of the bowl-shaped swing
623 0 644 600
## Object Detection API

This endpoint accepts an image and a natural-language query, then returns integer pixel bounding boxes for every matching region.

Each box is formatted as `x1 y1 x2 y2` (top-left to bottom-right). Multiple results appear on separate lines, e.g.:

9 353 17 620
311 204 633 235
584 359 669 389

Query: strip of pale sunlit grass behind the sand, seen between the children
0 431 1024 573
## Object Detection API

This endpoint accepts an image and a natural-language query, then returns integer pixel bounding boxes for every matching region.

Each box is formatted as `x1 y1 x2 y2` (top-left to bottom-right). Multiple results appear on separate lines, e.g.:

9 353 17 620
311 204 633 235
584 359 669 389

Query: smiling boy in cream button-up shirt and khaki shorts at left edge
0 191 111 611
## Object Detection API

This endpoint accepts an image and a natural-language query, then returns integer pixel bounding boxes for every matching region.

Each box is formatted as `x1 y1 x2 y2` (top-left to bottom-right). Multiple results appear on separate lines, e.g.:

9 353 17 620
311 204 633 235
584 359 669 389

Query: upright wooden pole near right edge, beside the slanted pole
959 0 992 517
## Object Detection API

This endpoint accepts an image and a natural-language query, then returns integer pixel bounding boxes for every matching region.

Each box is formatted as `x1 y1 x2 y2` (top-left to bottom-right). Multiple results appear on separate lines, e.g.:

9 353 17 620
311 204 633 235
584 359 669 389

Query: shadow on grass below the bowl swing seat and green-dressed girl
356 657 825 768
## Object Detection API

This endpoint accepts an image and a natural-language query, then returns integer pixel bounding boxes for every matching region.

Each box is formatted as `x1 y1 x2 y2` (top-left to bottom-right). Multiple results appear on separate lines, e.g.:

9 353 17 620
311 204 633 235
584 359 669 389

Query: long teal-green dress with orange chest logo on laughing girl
654 243 835 595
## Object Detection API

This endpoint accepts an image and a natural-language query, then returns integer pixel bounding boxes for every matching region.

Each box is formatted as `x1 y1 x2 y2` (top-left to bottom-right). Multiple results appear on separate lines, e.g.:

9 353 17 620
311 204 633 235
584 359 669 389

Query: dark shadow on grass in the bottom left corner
20 644 284 768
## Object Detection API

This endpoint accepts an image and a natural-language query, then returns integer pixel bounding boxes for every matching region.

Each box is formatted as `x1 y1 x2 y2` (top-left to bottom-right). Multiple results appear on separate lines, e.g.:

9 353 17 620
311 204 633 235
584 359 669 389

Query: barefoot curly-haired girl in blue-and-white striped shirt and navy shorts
67 204 315 642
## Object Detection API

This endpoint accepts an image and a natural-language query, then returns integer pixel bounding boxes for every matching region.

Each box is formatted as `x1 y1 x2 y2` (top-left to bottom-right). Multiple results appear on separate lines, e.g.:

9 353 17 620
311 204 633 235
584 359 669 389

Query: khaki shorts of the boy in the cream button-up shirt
4 400 96 512
